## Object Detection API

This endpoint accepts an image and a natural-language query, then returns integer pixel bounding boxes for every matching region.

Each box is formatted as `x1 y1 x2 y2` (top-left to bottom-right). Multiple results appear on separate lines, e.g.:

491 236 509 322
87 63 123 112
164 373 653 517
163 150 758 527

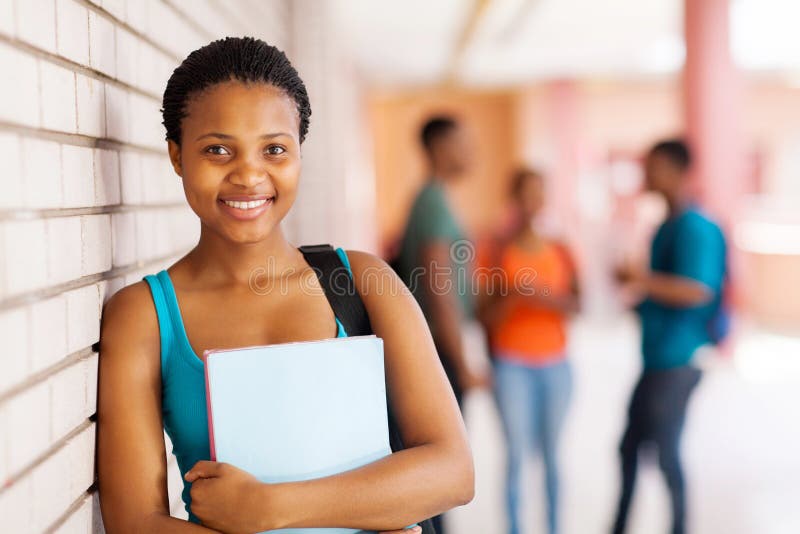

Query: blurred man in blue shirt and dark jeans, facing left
613 140 726 534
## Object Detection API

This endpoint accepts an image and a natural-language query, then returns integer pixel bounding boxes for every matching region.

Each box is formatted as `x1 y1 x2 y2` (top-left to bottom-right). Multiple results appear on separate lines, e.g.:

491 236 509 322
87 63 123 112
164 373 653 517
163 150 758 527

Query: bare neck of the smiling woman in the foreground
185 225 304 285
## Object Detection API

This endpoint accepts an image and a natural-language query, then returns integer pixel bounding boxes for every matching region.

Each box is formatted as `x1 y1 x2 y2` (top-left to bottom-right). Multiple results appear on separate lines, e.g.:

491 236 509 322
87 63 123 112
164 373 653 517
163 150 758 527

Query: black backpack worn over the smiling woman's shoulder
300 245 436 534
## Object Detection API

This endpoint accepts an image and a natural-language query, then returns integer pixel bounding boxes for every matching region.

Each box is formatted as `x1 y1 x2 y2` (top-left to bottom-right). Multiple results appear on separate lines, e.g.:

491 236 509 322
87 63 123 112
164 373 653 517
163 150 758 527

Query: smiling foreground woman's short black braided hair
161 37 311 145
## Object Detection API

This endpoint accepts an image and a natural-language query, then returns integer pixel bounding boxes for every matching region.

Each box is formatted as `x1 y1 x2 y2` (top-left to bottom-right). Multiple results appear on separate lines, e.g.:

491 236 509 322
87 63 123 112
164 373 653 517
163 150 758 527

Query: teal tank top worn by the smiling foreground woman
144 248 352 523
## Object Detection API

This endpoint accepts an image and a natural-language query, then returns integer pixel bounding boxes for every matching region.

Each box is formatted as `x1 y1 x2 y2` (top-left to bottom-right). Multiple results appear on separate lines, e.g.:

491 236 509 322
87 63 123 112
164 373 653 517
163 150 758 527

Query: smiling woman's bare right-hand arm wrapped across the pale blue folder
187 251 474 530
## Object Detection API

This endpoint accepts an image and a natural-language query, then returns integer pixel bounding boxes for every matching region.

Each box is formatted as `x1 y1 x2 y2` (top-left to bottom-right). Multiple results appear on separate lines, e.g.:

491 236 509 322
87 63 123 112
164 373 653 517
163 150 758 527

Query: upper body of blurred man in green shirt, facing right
398 117 487 410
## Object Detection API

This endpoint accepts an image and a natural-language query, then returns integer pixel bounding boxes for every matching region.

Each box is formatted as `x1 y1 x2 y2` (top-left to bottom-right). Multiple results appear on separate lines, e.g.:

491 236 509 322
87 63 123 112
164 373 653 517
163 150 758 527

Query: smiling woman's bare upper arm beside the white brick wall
97 282 219 534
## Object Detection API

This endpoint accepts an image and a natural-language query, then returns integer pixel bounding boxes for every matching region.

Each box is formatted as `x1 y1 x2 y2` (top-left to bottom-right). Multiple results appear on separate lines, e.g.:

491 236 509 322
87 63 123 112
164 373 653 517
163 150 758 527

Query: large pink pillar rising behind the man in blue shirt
683 0 747 227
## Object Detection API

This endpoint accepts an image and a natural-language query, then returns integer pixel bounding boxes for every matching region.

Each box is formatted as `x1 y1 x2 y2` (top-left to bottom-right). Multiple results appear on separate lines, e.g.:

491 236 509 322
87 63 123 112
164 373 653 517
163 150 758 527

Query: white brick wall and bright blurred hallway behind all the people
0 0 800 534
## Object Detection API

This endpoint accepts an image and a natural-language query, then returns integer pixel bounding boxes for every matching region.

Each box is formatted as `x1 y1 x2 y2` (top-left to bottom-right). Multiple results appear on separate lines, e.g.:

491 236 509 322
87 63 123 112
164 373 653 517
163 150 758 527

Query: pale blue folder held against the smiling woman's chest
203 336 391 534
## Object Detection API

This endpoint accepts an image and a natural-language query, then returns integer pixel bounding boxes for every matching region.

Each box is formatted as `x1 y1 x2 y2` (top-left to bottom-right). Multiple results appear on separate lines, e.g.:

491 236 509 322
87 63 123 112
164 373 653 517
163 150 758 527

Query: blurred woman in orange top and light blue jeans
481 169 578 534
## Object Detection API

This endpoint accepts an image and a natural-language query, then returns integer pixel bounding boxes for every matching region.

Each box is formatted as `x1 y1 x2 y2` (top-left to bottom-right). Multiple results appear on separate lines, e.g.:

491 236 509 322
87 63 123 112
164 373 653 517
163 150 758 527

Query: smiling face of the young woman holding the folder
169 81 300 243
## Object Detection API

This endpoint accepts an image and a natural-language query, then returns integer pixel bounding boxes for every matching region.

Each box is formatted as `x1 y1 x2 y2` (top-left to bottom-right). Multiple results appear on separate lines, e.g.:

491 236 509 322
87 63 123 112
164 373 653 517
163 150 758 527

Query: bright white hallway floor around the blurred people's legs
449 315 800 534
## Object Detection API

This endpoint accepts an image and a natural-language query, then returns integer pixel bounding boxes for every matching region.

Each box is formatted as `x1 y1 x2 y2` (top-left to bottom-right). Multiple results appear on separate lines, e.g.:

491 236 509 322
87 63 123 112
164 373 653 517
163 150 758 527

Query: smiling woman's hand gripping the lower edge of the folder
184 460 270 534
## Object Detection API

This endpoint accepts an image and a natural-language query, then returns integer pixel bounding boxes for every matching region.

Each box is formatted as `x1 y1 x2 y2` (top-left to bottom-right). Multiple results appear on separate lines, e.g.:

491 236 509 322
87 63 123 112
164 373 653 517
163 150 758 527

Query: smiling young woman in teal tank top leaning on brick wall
98 38 474 534
